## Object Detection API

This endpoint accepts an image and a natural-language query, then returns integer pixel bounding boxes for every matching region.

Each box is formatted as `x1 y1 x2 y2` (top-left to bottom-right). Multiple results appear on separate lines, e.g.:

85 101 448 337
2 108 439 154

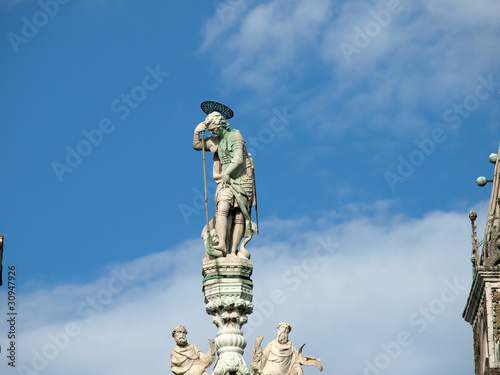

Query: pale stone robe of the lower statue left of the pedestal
170 344 213 375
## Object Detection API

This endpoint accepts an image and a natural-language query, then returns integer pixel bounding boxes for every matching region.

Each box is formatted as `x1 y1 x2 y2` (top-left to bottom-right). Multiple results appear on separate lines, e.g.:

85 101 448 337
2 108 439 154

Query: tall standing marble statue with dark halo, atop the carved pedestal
193 106 257 259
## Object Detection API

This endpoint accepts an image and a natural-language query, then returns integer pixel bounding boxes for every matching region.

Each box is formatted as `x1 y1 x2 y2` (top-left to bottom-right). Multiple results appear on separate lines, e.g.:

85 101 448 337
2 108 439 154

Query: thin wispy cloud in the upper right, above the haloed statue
202 0 500 145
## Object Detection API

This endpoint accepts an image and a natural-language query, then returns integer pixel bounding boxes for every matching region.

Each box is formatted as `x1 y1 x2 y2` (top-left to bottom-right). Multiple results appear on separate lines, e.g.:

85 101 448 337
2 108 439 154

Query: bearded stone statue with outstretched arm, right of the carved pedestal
250 323 323 375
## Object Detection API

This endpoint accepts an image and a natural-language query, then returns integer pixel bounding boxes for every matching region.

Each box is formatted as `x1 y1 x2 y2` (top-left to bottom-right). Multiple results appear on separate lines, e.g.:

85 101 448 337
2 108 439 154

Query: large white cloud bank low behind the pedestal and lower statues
0 203 486 375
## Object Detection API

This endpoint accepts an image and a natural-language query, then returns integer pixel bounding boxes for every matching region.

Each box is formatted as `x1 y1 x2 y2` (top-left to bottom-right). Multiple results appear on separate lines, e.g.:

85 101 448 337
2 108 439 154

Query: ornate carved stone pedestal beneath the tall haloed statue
202 256 253 375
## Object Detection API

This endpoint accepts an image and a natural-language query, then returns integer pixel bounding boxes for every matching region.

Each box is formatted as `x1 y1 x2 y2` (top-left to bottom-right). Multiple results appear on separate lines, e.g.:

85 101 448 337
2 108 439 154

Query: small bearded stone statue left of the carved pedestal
170 324 216 375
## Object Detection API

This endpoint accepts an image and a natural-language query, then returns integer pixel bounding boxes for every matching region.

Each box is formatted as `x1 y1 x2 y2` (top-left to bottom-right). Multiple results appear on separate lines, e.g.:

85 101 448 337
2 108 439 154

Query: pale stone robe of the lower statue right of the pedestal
261 340 303 375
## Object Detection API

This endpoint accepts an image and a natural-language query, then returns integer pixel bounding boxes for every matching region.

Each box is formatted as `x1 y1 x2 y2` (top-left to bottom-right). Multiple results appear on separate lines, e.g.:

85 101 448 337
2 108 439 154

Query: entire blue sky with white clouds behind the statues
0 0 500 375
